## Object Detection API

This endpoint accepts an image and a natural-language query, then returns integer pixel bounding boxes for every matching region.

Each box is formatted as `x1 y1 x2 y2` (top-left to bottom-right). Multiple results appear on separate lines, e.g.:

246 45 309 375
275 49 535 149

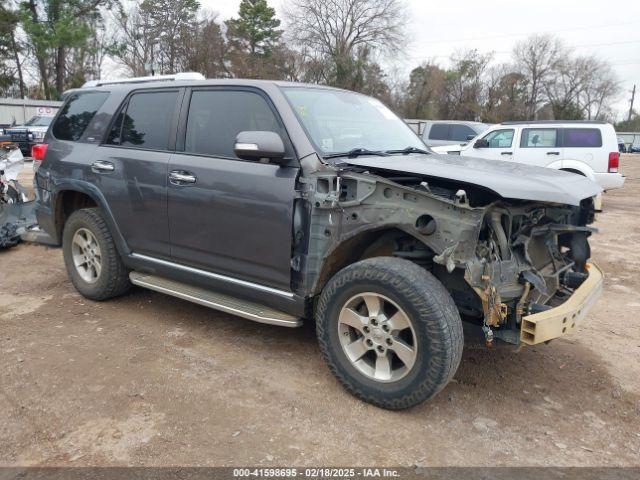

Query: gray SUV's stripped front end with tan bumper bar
465 199 602 345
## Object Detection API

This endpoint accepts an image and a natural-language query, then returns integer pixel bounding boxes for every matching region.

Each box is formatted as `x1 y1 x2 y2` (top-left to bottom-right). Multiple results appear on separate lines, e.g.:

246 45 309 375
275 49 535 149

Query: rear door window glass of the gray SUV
107 90 178 150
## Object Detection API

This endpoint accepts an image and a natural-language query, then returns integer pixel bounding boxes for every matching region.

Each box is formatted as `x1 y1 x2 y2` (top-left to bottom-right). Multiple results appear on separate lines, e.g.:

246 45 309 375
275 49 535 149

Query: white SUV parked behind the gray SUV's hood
432 120 624 190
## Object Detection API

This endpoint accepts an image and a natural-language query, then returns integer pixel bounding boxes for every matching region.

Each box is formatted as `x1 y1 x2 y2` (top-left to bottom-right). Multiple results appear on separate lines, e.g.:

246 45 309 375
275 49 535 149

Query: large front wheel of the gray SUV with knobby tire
316 257 464 410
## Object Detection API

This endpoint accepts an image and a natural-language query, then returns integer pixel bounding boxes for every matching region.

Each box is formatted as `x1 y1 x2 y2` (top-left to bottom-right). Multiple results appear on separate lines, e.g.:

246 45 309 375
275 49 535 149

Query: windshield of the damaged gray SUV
283 87 426 155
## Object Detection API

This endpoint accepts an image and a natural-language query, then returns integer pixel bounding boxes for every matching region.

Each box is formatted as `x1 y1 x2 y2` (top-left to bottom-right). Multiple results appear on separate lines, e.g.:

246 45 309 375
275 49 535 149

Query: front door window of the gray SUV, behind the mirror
184 90 291 158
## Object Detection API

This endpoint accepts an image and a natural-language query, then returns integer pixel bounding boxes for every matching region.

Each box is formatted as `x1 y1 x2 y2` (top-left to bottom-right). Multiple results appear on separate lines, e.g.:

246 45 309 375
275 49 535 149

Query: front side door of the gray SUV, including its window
168 87 299 290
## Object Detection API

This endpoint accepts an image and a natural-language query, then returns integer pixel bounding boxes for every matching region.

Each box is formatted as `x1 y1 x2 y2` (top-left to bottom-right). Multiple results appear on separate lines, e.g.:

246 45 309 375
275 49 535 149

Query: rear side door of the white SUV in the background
514 127 562 168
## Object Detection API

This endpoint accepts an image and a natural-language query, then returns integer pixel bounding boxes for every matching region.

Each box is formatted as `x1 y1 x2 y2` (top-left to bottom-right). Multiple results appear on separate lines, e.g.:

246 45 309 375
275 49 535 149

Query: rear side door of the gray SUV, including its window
92 89 182 257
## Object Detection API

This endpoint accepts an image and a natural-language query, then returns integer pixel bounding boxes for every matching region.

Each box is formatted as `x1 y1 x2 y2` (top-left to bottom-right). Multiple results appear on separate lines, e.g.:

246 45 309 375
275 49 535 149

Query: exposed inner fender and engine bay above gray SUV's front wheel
292 161 595 344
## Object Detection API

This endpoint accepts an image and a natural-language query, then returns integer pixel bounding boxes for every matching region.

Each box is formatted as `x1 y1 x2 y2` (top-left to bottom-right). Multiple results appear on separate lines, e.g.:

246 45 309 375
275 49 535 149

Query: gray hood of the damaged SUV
345 154 602 206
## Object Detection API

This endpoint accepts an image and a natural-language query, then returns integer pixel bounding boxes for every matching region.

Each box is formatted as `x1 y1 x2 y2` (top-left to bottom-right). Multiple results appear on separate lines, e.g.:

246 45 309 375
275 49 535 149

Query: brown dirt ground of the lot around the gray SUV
0 155 640 466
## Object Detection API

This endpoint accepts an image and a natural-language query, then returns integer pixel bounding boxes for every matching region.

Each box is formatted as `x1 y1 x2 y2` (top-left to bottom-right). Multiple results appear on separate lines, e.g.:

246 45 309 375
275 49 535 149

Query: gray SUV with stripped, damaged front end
36 78 602 409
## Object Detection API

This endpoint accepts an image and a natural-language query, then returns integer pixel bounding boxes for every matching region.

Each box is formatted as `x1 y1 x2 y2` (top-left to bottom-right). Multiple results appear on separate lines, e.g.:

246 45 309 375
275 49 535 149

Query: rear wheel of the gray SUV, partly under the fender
62 208 131 300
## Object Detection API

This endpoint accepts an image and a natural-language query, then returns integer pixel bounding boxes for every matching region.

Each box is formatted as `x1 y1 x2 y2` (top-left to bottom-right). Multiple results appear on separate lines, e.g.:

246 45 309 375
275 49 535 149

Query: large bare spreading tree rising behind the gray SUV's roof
285 0 406 87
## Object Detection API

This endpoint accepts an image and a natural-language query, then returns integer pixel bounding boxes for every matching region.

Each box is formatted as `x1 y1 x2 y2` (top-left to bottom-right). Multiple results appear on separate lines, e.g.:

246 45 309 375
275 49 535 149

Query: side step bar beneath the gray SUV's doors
129 272 302 327
